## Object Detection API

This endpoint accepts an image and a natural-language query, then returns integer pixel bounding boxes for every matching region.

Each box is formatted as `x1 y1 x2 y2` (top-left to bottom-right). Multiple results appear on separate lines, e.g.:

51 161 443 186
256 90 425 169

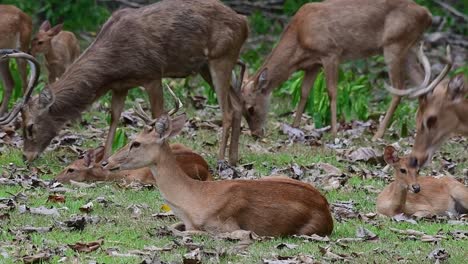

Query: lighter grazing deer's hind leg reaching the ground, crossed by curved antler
372 46 405 140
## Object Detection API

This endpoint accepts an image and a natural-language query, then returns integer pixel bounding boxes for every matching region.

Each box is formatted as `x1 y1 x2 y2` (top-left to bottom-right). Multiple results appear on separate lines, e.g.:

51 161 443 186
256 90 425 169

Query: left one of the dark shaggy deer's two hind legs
209 59 234 160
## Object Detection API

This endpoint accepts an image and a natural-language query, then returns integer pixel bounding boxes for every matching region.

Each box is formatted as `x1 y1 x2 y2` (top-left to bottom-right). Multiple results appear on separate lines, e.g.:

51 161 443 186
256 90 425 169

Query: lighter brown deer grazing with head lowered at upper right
242 0 431 138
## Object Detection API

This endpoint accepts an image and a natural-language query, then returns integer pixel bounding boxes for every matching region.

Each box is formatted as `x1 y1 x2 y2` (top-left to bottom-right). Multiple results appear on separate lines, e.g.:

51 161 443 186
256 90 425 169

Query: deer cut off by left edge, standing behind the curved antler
0 5 32 114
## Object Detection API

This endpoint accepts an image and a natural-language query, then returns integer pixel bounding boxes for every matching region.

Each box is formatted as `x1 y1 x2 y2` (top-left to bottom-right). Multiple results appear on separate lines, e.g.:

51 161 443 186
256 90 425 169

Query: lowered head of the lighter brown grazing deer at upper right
241 68 270 137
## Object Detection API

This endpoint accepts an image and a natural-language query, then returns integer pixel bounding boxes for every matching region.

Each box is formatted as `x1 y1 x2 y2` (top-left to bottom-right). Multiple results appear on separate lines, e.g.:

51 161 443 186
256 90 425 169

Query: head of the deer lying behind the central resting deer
55 147 107 183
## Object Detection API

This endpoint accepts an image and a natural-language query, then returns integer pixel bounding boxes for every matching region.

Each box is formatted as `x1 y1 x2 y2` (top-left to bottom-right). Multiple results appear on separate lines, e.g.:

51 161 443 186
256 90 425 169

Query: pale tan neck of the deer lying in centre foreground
150 143 200 208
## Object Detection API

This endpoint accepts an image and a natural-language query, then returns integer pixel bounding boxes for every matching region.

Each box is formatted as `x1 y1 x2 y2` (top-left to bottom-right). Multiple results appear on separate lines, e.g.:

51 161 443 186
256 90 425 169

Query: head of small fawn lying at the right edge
384 146 421 193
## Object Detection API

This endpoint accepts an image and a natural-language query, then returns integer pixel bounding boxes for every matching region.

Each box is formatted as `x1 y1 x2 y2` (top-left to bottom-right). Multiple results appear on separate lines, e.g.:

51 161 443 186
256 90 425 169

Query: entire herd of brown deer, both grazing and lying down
0 0 468 236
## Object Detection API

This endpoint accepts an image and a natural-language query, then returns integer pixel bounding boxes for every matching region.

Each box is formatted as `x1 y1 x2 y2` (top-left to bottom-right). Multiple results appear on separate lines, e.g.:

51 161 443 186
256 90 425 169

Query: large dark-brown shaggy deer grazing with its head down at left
0 0 248 163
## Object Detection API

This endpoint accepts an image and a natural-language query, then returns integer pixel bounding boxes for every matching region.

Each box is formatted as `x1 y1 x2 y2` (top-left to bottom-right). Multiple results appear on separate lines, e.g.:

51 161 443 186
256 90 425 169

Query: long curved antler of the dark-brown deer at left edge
0 49 40 125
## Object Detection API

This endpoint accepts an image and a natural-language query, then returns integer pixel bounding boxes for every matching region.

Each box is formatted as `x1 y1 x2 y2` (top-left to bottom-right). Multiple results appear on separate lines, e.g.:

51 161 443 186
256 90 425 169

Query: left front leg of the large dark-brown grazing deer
102 90 127 160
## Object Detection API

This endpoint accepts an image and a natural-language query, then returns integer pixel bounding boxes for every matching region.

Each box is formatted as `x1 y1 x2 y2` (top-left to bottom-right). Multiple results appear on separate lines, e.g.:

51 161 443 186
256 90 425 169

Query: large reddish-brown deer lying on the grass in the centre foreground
102 105 333 236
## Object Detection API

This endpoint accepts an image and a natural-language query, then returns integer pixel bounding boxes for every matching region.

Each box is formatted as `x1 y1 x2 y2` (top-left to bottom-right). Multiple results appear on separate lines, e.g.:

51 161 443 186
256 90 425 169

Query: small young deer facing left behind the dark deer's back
31 21 80 83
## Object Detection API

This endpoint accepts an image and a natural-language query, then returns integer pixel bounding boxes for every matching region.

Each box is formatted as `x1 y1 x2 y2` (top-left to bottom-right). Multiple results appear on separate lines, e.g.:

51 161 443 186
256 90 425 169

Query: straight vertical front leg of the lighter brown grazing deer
323 57 338 137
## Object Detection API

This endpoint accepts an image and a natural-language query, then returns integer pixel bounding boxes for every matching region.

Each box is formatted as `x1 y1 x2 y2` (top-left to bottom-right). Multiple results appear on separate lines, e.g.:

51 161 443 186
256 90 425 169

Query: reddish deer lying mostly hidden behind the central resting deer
55 144 213 185
